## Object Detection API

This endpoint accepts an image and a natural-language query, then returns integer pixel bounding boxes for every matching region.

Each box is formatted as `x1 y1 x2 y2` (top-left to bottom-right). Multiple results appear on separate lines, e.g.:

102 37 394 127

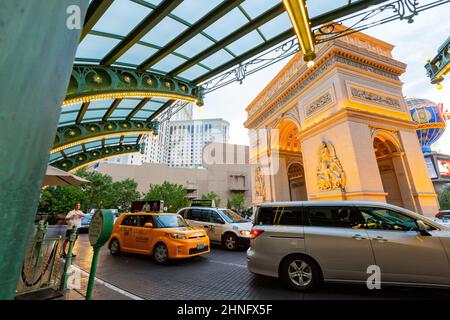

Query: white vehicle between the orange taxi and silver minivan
178 207 252 250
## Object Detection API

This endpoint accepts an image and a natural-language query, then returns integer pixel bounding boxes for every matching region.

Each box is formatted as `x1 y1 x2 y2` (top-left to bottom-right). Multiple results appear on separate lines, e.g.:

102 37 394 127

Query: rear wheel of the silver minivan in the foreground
280 256 321 291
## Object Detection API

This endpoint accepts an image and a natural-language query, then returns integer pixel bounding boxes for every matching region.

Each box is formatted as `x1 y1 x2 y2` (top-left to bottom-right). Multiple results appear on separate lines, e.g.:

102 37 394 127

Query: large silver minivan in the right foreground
247 201 450 291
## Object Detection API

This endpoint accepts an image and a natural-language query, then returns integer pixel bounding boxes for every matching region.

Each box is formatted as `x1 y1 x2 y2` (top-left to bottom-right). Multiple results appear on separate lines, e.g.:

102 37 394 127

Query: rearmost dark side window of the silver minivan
255 207 302 226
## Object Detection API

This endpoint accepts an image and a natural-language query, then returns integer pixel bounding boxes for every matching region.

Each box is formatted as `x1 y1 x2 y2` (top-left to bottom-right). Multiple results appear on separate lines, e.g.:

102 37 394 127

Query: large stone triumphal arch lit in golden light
245 27 438 215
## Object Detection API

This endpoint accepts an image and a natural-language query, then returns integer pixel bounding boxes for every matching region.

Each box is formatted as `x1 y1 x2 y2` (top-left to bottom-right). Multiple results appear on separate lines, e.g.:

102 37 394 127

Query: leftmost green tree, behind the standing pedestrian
39 186 87 213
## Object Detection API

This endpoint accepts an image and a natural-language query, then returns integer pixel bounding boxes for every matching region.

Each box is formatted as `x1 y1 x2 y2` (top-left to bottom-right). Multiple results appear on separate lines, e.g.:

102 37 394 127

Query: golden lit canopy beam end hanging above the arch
283 0 316 63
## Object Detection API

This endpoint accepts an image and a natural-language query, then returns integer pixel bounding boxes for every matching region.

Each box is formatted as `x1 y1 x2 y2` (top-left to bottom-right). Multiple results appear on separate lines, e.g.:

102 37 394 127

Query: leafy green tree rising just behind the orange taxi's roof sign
144 181 189 212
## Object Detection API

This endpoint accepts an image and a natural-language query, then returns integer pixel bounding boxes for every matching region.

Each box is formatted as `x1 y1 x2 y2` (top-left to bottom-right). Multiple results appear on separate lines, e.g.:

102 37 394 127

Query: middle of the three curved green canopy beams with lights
50 120 159 155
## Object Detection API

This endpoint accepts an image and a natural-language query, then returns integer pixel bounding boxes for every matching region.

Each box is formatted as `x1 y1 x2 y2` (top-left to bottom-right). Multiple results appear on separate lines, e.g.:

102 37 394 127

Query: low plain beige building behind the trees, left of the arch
95 144 252 207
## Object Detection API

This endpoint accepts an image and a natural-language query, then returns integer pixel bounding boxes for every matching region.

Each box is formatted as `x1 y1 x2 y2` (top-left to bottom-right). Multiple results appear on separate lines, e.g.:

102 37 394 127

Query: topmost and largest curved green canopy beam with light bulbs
63 64 203 107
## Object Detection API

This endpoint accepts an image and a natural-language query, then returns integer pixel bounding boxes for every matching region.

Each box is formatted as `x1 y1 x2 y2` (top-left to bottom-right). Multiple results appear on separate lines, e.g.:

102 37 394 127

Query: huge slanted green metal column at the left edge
0 0 89 300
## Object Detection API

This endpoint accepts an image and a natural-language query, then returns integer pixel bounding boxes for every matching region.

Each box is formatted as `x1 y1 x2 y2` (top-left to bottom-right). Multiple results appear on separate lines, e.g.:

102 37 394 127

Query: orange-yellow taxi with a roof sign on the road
109 212 210 264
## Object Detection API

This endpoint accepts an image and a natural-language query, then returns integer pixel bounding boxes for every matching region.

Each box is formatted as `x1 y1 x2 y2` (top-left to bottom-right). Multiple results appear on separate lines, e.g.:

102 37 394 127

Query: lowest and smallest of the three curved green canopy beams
50 144 141 172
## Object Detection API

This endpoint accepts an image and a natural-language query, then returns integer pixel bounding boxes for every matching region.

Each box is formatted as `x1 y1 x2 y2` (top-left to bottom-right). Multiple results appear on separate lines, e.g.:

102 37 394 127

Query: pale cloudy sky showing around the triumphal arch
194 4 450 154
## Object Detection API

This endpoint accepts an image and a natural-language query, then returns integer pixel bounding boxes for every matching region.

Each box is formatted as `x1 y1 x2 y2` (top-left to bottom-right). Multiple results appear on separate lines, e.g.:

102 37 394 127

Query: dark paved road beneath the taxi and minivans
73 235 450 300
